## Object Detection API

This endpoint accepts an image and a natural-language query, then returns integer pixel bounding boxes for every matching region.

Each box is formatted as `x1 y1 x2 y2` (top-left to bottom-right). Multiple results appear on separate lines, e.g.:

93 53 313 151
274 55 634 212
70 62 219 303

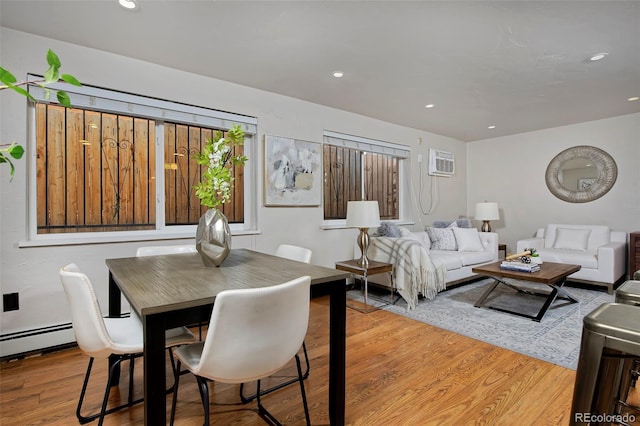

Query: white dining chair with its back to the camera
171 276 311 425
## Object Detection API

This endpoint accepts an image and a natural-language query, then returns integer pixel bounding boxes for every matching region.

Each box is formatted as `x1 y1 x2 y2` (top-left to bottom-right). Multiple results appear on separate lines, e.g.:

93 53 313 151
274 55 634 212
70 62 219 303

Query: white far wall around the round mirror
467 113 640 251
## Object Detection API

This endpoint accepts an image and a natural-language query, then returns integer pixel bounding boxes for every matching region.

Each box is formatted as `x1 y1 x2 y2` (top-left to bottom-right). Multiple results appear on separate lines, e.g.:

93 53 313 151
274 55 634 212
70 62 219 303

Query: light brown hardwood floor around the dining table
0 297 636 426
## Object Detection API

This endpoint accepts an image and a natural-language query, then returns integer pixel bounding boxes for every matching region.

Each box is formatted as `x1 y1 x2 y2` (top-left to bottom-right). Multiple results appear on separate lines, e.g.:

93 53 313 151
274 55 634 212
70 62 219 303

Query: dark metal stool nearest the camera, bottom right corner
570 303 640 425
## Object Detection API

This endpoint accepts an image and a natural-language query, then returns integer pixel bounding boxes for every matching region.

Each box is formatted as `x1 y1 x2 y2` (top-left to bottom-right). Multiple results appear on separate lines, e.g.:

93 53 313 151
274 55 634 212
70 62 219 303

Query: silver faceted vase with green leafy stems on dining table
193 125 247 266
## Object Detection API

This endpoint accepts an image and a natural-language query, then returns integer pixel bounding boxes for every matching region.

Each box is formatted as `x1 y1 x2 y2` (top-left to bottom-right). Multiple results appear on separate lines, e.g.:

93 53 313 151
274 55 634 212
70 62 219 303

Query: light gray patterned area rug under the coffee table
347 279 614 370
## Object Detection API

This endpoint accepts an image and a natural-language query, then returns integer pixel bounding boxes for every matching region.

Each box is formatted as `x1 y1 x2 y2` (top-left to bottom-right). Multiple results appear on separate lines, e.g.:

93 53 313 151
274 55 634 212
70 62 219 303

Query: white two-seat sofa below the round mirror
516 224 627 294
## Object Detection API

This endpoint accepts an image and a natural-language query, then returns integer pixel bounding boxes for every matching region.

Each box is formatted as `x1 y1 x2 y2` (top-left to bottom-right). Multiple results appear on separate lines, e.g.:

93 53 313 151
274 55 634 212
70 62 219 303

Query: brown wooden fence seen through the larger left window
36 104 244 234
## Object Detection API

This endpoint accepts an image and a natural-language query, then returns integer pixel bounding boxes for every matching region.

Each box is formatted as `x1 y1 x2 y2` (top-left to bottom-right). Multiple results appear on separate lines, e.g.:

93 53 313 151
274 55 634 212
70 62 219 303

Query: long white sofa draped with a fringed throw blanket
354 228 498 305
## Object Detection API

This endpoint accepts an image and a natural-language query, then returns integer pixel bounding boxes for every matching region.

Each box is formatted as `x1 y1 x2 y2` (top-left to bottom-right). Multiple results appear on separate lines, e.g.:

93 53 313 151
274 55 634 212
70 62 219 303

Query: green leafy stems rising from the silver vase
193 124 247 209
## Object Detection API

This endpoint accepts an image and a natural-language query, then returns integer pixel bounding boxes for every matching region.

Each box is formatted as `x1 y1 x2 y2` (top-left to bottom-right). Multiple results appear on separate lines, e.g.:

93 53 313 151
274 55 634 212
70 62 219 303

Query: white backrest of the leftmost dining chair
60 263 113 358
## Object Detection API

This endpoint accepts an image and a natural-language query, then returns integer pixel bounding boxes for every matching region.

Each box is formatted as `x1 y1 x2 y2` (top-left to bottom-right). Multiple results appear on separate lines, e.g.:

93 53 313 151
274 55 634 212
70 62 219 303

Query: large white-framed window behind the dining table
29 76 257 241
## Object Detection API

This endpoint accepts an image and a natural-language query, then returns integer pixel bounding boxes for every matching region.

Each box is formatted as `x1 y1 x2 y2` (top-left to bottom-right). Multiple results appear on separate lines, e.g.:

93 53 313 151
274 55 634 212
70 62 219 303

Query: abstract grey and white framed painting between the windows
264 135 322 206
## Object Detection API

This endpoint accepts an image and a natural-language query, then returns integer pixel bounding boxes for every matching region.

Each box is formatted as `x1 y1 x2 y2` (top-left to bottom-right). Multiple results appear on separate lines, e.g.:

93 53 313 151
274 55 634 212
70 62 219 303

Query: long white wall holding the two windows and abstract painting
0 28 467 356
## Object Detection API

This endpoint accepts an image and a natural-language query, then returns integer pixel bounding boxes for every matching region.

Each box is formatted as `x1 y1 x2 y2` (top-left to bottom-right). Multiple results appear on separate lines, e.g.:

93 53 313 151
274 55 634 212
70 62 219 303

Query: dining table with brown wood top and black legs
106 249 349 426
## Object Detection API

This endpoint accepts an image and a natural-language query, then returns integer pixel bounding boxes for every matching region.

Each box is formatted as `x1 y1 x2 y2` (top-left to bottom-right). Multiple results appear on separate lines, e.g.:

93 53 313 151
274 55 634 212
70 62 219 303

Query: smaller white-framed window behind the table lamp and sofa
323 131 410 221
